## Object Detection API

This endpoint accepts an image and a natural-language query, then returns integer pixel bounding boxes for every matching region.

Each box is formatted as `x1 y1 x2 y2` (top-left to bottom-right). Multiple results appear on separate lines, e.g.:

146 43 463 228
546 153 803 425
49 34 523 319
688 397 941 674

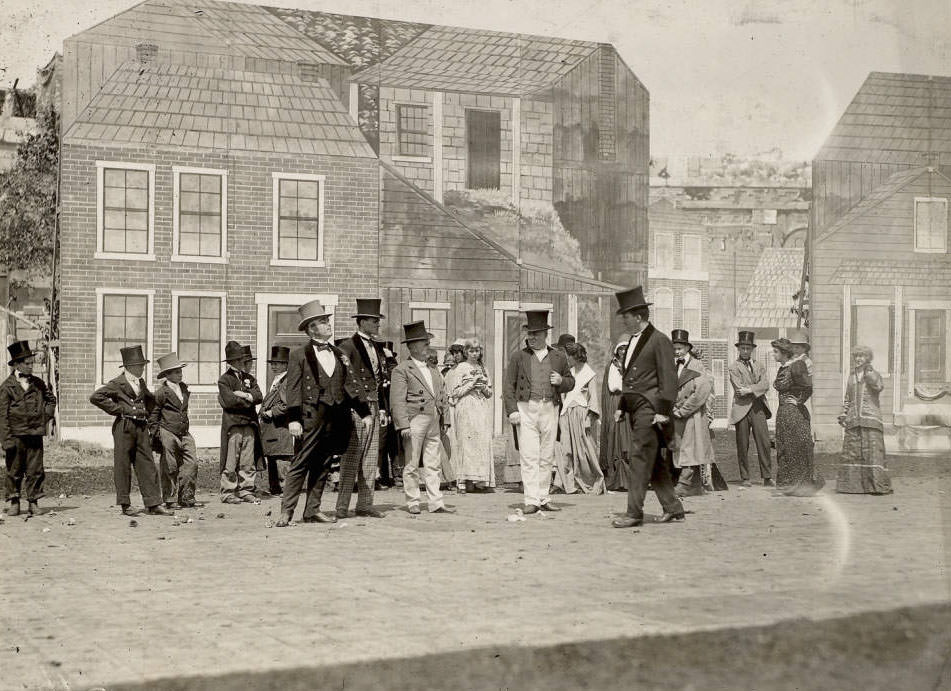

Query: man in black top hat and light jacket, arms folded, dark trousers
729 331 775 487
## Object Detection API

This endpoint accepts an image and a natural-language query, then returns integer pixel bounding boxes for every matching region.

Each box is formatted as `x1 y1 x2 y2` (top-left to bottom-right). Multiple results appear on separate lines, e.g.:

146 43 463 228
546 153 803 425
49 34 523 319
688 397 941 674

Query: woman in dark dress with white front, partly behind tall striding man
599 334 632 492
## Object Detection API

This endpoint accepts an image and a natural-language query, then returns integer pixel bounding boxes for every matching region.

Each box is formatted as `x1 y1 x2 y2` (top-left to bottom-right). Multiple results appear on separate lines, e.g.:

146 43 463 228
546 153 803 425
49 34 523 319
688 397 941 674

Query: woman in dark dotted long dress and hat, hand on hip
772 338 824 497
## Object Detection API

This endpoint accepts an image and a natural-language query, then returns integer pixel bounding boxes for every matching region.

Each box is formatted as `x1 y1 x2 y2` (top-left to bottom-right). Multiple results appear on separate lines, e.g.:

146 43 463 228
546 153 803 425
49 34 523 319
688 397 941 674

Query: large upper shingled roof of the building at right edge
816 72 951 166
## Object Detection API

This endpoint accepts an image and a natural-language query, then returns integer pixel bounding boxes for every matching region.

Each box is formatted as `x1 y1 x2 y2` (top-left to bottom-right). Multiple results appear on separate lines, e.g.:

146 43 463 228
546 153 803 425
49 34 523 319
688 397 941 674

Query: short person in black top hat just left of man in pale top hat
259 345 294 494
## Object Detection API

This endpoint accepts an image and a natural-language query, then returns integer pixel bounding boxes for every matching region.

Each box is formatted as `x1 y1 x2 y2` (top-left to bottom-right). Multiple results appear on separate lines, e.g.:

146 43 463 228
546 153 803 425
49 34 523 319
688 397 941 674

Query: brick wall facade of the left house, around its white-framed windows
60 143 379 440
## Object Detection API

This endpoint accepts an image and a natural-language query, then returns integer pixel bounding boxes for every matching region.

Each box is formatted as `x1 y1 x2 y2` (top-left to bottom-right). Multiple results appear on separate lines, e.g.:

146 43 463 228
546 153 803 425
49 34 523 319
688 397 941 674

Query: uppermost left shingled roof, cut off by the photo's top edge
75 0 346 65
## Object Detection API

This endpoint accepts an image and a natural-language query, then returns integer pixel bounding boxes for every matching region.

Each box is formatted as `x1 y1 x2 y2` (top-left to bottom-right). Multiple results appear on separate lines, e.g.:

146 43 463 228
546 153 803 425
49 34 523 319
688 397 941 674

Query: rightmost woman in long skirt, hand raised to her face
835 346 892 494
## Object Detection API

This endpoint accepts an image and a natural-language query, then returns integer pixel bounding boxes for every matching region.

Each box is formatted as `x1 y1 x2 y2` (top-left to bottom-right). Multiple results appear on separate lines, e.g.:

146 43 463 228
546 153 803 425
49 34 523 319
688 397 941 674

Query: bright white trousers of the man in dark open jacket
517 401 558 506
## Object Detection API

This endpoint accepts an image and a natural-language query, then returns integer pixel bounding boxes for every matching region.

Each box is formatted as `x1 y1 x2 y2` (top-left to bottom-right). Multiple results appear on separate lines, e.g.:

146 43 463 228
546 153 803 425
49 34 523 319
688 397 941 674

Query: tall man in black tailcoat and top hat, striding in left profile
613 286 684 528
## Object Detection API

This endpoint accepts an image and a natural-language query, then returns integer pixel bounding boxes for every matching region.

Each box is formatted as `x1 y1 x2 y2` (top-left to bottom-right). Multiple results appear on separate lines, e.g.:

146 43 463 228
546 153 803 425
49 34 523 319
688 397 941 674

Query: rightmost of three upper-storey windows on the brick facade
275 178 321 261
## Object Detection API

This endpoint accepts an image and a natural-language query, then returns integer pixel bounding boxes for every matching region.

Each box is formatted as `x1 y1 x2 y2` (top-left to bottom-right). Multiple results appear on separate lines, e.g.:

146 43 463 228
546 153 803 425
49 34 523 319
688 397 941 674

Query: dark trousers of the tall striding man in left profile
627 401 684 519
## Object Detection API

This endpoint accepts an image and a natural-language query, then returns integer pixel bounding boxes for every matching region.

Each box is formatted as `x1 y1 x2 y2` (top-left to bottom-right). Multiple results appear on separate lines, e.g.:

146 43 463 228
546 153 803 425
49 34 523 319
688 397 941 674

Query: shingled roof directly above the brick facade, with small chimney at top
64 61 376 158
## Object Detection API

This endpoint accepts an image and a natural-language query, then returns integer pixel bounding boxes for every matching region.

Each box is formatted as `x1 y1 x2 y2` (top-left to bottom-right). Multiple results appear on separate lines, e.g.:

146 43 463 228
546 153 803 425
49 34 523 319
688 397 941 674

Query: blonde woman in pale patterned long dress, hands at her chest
446 338 495 492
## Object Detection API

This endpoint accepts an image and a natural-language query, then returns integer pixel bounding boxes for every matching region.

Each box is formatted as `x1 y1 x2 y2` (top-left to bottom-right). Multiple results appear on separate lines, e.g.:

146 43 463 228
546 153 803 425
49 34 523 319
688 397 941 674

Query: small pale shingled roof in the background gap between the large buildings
736 247 804 328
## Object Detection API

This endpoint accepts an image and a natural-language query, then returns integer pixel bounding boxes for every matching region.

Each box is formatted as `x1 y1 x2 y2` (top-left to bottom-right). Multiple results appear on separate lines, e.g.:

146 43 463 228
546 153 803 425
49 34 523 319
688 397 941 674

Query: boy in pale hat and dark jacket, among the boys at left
149 353 198 509
